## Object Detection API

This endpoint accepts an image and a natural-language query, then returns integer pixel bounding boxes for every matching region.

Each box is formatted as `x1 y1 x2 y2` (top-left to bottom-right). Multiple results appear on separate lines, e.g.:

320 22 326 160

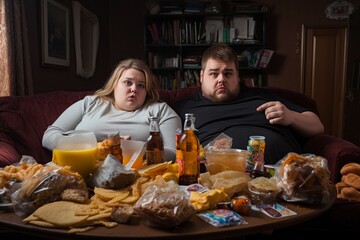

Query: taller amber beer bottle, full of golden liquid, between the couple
179 113 200 185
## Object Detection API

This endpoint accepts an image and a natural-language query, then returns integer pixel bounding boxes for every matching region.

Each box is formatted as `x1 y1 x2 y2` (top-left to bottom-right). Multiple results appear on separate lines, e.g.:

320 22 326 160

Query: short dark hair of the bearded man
201 43 238 70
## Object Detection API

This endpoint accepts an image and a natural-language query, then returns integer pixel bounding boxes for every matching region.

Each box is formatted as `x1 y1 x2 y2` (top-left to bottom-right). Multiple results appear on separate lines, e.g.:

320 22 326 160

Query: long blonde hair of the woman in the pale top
95 58 160 104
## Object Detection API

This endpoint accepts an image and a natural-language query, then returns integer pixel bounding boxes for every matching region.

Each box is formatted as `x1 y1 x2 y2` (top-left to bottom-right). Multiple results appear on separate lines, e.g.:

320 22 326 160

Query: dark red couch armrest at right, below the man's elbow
303 134 360 183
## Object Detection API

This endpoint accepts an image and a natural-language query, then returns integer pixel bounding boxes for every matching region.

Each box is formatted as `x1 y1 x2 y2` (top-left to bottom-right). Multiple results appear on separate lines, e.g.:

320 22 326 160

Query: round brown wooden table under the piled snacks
0 186 336 240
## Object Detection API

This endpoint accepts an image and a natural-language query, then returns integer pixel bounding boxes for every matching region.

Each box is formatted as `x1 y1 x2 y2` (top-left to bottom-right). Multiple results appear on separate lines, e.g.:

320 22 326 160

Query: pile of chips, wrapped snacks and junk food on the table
0 133 332 233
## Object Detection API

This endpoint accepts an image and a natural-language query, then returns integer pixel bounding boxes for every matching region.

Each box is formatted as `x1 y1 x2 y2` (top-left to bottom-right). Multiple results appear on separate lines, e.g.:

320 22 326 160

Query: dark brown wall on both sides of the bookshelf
24 0 360 93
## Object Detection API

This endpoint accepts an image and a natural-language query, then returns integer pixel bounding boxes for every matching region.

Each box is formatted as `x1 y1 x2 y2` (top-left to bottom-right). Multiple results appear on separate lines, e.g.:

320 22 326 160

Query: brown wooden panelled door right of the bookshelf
301 26 347 137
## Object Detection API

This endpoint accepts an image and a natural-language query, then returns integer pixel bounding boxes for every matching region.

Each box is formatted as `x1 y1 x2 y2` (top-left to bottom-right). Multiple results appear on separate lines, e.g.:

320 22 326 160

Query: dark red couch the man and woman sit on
0 88 360 236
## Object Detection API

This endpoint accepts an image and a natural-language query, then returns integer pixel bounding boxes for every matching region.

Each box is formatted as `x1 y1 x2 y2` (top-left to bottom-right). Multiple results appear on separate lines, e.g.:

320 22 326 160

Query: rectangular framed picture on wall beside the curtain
41 0 70 67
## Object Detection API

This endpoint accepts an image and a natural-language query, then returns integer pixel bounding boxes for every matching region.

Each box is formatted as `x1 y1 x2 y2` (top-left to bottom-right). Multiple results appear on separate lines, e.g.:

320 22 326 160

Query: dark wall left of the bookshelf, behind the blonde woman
24 0 144 93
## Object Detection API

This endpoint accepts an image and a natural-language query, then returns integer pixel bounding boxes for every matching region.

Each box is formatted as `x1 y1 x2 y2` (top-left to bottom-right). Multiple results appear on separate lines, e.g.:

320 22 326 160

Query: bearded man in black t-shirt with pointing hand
175 44 324 163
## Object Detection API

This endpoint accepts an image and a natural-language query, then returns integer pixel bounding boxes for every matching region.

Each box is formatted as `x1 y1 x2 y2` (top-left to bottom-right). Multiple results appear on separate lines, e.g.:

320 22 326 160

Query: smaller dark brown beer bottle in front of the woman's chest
145 116 164 165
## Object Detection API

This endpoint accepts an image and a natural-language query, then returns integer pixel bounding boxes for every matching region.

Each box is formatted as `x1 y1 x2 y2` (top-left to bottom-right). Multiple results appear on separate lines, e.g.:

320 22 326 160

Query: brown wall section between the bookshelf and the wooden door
257 0 359 92
